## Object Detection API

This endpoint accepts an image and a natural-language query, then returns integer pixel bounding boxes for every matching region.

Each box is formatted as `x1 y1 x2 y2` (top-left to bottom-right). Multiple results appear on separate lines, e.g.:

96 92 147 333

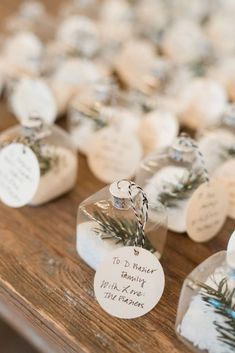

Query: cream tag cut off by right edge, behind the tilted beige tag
214 159 235 219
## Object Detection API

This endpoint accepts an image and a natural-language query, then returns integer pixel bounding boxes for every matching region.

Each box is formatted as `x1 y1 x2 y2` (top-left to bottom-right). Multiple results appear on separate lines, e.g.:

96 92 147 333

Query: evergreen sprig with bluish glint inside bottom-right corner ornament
196 278 235 348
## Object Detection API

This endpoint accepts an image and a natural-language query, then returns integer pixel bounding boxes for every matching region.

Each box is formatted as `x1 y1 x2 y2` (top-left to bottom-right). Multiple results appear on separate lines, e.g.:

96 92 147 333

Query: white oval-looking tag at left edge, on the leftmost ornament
0 143 40 207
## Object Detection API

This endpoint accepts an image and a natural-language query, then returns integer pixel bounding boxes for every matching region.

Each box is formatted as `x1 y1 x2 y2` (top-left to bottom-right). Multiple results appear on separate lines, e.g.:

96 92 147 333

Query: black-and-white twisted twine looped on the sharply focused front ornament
117 179 149 255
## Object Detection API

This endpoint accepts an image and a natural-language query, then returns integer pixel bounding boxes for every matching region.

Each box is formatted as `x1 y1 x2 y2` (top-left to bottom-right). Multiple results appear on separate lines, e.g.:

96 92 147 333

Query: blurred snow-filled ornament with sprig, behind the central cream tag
68 81 140 155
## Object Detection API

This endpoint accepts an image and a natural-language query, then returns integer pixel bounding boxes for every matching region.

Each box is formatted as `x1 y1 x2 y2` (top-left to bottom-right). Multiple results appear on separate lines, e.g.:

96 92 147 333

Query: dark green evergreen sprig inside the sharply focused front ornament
93 211 156 252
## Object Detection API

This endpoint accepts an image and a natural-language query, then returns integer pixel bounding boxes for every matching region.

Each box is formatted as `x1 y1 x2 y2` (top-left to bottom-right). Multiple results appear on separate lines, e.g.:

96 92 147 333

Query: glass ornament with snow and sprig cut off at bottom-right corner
175 233 235 353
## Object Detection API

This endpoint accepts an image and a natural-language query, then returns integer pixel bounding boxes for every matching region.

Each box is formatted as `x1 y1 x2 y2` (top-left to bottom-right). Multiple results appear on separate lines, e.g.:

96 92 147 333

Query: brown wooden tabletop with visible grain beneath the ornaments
0 0 235 353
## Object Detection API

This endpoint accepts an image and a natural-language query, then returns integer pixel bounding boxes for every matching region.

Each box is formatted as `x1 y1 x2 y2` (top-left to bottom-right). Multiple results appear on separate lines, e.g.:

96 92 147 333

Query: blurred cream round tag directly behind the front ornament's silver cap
87 127 142 183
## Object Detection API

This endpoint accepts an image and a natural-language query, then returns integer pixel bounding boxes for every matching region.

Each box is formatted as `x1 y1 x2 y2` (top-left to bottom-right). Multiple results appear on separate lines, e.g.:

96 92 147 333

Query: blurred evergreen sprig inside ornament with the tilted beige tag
158 170 205 207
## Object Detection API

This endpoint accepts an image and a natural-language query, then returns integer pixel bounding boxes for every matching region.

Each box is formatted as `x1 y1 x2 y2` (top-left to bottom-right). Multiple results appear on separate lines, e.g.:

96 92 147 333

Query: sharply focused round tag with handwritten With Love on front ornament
94 246 165 319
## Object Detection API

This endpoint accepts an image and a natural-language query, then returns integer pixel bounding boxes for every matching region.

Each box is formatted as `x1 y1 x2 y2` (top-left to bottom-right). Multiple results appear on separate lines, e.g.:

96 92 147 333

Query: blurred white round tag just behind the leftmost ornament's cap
10 78 57 124
